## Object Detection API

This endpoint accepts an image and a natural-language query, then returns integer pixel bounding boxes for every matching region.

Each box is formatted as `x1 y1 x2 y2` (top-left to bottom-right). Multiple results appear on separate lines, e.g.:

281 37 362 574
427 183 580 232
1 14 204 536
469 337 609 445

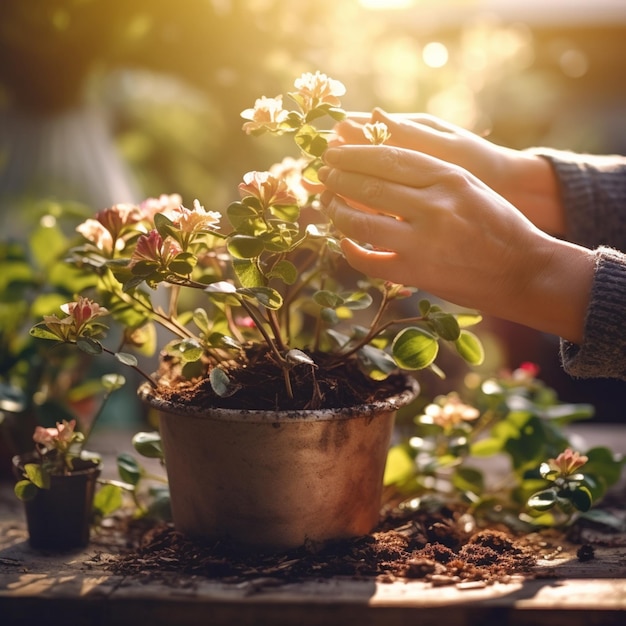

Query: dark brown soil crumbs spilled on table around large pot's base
109 500 538 587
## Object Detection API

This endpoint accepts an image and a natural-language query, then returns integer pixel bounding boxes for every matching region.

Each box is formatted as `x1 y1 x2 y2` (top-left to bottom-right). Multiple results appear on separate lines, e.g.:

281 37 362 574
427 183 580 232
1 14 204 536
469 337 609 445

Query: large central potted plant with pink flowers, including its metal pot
31 72 482 548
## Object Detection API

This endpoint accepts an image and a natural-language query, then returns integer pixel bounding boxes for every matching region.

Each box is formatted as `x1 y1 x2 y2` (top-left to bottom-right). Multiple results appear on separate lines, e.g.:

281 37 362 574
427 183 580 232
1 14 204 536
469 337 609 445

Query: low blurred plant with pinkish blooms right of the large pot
385 364 624 530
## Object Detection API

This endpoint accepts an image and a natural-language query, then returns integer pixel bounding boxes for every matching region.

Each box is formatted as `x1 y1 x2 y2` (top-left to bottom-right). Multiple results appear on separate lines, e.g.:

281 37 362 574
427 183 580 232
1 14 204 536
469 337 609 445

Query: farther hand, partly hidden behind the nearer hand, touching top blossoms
335 109 565 234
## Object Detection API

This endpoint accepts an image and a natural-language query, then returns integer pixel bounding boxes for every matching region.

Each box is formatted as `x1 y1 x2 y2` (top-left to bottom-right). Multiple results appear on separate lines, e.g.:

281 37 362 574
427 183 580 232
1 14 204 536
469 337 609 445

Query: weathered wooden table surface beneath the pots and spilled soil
0 424 626 626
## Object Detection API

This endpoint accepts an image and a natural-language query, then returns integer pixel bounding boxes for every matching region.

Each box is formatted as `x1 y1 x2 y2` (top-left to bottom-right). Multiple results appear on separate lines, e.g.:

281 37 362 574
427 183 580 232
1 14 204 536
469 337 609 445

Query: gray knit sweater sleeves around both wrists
533 148 626 380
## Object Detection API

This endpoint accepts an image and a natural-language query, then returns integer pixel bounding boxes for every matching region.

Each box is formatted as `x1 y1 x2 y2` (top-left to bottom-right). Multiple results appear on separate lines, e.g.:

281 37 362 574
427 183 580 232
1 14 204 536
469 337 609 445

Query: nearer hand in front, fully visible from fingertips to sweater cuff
319 145 593 342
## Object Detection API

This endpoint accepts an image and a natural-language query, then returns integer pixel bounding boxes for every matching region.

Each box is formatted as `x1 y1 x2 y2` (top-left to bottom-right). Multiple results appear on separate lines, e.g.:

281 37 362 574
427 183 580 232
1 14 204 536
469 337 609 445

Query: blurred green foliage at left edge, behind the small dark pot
0 201 130 466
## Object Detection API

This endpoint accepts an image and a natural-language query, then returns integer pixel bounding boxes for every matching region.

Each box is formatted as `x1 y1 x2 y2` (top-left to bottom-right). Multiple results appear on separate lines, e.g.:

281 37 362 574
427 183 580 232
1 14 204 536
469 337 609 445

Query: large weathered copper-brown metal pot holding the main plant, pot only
140 379 418 550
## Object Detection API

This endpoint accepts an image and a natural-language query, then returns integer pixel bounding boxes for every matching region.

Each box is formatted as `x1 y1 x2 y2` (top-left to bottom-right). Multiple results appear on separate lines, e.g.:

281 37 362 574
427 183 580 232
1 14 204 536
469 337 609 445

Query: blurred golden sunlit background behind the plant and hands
0 0 626 438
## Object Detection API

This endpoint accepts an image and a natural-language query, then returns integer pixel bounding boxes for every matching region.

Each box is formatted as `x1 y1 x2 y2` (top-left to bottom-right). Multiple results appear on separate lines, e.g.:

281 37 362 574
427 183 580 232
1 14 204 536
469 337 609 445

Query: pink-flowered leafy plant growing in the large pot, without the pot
31 72 482 408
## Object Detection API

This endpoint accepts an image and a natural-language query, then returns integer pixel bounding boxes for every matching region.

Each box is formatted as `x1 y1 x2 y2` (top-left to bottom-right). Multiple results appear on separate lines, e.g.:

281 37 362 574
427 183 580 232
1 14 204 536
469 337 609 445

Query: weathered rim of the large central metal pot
137 375 420 423
